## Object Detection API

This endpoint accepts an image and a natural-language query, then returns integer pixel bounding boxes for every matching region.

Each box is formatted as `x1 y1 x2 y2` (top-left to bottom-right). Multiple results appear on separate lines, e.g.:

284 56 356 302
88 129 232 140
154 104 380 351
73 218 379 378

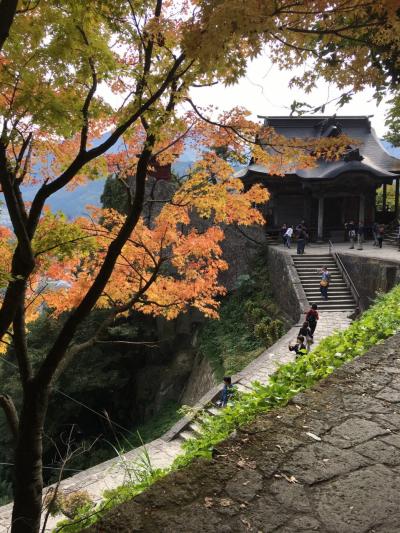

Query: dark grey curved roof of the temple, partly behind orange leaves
248 116 400 179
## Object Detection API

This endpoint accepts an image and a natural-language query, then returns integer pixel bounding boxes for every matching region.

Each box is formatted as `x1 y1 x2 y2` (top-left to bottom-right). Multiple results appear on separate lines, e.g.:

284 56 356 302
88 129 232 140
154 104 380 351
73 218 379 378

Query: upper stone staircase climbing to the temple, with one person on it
293 254 356 312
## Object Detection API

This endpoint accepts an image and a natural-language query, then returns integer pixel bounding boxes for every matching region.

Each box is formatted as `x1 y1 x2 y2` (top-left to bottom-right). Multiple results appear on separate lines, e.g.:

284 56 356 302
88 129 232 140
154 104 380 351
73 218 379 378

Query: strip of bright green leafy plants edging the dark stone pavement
55 285 400 532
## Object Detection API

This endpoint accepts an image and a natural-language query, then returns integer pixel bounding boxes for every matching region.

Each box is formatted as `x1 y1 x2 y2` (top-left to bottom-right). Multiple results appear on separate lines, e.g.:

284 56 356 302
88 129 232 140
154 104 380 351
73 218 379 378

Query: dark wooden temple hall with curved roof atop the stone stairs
240 116 400 240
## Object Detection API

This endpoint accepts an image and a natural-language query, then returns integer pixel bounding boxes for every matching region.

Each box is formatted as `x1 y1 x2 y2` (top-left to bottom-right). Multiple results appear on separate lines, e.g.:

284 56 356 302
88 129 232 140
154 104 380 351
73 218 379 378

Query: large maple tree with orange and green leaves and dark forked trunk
0 0 396 533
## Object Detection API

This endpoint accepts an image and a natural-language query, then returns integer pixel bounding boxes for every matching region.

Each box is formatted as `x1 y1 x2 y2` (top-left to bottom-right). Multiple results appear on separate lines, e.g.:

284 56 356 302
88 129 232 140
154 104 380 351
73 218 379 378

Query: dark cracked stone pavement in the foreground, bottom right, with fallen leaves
87 335 400 533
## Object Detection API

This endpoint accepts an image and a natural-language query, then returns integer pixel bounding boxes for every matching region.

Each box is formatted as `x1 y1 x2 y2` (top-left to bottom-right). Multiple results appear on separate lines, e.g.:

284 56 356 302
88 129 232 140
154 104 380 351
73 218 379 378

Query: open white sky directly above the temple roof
192 57 387 137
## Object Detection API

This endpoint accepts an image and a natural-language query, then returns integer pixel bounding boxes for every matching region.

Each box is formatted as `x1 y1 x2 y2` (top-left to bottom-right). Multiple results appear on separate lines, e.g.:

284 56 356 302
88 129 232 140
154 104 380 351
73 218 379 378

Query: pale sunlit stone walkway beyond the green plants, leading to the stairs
0 312 351 533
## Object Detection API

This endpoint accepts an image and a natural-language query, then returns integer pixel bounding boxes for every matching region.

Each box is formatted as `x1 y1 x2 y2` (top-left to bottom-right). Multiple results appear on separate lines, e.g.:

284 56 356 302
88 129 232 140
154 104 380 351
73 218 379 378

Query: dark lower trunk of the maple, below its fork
11 382 49 533
